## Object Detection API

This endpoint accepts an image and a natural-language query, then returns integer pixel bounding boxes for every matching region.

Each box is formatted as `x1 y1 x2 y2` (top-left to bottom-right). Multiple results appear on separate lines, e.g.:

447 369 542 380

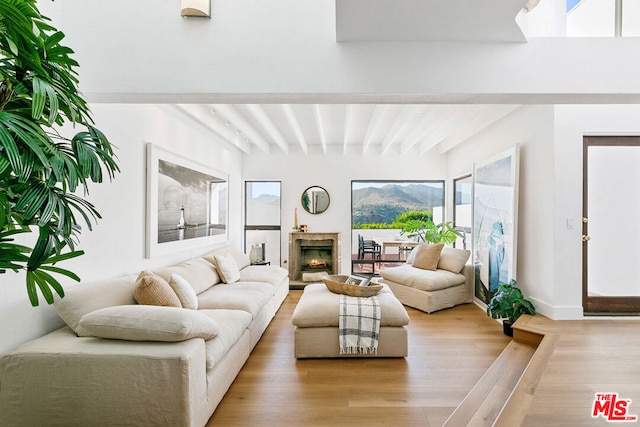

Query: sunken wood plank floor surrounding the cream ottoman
207 291 510 427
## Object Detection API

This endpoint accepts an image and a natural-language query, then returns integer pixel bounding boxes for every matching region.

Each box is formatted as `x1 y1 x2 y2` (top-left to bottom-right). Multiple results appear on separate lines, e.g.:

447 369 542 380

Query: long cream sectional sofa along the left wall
0 248 289 427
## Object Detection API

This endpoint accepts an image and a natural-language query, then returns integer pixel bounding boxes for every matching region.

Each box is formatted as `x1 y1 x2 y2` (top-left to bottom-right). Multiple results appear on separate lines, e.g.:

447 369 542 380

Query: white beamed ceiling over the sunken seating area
172 104 519 155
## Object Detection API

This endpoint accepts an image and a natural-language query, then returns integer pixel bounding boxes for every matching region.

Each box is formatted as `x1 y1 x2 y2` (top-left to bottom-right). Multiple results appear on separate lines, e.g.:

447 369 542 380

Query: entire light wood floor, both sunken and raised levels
207 291 640 427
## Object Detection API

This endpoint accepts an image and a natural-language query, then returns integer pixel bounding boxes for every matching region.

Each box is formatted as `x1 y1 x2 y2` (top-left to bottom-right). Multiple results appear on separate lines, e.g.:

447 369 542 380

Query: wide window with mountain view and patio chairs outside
351 180 445 274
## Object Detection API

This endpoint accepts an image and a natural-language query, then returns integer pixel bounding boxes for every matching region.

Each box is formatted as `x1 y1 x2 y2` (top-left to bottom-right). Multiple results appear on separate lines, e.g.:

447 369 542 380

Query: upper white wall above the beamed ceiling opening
38 0 640 103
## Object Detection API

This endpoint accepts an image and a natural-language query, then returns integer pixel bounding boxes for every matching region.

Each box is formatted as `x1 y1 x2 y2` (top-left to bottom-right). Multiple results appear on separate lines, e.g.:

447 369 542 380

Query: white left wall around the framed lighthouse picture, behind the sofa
0 104 242 354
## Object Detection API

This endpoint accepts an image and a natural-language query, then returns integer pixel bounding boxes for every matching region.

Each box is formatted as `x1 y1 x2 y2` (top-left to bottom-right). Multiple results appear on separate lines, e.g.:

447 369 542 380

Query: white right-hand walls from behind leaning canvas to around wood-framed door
448 105 640 320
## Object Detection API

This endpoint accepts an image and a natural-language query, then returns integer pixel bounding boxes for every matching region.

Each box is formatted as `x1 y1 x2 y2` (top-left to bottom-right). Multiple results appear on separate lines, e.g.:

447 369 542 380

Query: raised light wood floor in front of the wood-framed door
522 316 640 427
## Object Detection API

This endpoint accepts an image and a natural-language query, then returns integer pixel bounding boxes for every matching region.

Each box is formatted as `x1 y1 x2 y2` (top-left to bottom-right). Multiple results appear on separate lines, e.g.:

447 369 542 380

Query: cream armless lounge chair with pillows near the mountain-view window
379 243 474 313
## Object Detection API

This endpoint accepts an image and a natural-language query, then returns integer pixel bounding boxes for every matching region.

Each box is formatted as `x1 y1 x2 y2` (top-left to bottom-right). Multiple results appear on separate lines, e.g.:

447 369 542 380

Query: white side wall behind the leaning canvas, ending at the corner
448 106 554 314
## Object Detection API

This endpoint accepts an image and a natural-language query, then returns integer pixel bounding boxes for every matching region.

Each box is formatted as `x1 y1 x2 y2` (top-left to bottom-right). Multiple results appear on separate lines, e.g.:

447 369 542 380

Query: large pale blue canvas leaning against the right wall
473 146 520 304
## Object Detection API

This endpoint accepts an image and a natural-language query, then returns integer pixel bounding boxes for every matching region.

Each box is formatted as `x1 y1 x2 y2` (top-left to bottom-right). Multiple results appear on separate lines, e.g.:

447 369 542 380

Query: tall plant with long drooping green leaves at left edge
0 0 119 306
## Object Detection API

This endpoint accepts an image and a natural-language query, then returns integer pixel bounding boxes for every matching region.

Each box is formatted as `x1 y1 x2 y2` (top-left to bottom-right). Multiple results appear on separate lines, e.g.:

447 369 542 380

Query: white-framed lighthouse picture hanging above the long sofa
145 143 228 258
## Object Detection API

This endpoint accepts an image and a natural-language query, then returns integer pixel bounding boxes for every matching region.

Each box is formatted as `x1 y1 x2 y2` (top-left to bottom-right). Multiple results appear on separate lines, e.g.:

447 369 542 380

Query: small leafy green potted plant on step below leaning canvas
487 280 536 337
